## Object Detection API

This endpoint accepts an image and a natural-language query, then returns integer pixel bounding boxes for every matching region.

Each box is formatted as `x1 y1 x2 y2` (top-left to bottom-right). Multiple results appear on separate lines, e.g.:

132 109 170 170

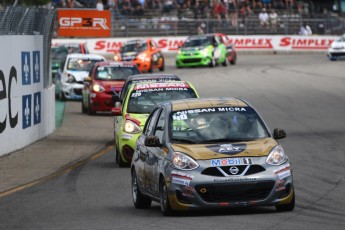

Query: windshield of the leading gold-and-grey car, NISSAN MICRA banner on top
169 107 269 144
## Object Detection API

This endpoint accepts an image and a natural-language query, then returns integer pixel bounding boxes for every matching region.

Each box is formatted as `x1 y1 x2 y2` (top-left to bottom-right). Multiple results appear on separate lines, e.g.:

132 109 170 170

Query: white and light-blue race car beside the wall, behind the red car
53 54 106 101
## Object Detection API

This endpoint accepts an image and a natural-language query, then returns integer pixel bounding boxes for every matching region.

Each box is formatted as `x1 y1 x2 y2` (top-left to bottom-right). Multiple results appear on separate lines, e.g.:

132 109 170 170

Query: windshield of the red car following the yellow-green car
96 66 140 81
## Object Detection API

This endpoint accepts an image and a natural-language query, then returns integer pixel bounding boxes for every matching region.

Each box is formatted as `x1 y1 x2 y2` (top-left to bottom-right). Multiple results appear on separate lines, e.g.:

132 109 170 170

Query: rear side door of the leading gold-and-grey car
135 108 161 195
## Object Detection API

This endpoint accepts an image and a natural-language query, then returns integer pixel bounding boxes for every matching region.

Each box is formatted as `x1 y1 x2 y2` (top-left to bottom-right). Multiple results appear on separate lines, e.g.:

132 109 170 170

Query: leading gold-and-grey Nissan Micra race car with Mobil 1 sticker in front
131 98 295 215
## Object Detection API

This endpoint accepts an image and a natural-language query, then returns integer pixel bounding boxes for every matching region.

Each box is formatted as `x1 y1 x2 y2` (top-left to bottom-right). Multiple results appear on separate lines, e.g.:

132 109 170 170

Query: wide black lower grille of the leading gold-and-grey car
195 181 274 202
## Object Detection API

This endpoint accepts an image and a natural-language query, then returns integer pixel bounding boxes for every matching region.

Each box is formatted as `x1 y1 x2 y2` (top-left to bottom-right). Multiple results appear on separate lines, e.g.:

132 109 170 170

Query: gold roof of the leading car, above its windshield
169 97 250 111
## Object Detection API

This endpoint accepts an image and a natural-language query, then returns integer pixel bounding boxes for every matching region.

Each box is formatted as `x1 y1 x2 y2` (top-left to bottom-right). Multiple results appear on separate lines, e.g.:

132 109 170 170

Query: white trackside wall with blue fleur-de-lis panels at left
0 35 55 156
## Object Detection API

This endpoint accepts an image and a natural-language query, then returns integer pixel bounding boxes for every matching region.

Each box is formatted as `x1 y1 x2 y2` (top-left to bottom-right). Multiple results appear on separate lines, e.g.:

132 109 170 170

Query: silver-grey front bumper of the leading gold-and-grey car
167 158 294 210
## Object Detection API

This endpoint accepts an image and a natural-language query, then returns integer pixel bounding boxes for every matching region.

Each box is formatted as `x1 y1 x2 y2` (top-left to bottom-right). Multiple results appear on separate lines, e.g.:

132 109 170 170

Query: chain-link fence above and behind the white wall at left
0 6 57 87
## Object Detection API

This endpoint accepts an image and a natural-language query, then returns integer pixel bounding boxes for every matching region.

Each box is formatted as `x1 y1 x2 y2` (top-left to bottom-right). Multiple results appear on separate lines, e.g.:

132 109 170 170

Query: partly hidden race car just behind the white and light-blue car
51 42 90 79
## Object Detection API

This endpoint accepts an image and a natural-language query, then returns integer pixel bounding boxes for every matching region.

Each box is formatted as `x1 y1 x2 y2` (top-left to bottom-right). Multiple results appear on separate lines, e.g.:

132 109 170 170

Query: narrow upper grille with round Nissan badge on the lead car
201 165 265 177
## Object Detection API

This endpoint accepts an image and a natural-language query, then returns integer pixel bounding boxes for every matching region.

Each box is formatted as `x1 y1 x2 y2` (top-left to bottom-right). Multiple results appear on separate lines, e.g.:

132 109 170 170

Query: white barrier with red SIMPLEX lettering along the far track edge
52 35 339 55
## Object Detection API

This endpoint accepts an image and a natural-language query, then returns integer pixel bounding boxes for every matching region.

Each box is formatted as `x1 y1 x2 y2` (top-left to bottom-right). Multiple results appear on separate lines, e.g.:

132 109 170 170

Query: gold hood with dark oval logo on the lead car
171 138 278 160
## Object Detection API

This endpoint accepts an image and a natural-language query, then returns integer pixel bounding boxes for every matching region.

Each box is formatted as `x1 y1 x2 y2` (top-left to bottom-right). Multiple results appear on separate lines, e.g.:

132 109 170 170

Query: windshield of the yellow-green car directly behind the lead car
127 88 197 113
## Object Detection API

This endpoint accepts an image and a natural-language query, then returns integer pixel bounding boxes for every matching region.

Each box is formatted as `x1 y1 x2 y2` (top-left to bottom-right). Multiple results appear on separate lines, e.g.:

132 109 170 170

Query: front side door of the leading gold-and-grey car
145 109 166 197
